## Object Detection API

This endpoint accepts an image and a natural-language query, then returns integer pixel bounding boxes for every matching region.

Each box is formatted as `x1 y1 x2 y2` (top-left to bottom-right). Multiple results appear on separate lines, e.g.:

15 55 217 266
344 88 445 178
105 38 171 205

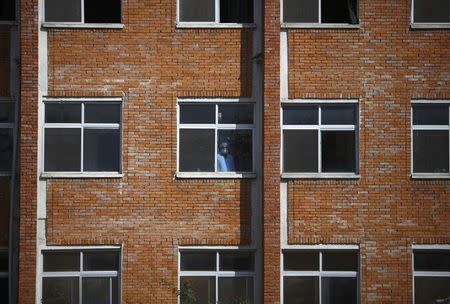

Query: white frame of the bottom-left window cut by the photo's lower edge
39 246 122 304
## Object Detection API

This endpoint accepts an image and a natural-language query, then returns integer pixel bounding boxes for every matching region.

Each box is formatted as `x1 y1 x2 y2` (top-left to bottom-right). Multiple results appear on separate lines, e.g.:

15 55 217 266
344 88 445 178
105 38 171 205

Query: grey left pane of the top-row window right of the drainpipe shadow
283 0 319 23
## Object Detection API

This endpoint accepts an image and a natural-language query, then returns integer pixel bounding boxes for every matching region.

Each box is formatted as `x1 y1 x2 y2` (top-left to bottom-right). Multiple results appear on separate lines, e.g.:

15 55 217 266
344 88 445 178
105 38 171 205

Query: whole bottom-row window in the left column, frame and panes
42 249 120 304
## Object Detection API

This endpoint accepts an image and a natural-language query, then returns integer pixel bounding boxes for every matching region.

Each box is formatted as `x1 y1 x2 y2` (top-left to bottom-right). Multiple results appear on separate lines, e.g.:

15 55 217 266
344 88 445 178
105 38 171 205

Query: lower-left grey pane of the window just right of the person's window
283 130 318 172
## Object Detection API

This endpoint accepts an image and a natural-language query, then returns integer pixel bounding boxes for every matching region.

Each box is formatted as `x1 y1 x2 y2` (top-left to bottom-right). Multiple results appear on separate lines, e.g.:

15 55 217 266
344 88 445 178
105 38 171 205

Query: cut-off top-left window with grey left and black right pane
45 0 122 23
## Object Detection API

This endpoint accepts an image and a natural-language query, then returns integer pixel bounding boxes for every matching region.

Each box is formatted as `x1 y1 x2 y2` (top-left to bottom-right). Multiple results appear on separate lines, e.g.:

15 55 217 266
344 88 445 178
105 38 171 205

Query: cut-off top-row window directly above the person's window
178 0 253 23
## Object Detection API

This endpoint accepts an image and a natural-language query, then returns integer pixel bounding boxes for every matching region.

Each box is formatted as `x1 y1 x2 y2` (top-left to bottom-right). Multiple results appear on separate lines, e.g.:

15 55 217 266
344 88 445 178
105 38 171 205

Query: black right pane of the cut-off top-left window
84 0 122 23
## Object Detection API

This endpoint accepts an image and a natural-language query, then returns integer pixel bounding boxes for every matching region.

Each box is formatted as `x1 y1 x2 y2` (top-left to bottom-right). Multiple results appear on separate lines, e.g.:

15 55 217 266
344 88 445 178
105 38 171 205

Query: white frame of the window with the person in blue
176 98 256 178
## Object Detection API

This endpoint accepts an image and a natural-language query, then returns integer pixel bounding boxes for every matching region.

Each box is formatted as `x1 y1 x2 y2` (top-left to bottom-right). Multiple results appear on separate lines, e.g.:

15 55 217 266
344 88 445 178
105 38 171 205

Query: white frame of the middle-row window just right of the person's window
280 99 360 179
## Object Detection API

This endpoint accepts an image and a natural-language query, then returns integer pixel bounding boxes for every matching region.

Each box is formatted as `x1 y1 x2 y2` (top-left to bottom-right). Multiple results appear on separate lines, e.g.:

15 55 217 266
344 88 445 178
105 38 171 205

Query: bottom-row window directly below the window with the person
178 250 254 304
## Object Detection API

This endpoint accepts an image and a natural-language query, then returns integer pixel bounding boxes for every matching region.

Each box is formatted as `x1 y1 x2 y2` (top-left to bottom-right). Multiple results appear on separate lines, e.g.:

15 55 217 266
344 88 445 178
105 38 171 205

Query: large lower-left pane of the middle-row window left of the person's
44 128 81 171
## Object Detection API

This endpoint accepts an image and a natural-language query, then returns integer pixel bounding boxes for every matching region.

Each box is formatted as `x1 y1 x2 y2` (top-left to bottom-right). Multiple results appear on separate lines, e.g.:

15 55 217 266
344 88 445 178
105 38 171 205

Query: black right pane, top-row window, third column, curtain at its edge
322 0 358 24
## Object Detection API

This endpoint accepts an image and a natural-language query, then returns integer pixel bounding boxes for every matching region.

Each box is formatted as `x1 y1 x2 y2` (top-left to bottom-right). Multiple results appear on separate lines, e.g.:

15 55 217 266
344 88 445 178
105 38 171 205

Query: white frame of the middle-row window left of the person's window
41 97 123 178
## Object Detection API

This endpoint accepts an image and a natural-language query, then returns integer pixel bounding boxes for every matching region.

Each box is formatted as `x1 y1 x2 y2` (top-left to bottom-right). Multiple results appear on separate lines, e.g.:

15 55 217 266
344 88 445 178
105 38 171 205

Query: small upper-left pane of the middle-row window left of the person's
45 103 81 123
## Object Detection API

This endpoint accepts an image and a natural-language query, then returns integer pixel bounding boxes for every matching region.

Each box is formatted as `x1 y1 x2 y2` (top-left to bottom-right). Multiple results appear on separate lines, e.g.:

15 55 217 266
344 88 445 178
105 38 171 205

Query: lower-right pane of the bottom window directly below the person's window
219 278 253 304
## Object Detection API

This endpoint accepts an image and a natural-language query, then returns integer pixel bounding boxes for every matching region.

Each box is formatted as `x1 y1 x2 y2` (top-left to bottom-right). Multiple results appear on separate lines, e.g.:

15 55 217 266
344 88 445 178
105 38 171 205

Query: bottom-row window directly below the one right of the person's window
283 250 359 304
